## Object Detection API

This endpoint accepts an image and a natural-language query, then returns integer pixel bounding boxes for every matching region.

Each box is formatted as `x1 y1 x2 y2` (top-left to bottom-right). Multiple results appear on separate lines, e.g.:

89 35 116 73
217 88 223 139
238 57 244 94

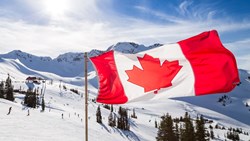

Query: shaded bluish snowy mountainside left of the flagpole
0 50 87 77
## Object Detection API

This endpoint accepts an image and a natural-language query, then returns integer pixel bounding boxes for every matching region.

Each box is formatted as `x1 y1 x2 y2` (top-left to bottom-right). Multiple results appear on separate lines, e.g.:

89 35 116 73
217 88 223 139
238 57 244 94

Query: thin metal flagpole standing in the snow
84 52 88 141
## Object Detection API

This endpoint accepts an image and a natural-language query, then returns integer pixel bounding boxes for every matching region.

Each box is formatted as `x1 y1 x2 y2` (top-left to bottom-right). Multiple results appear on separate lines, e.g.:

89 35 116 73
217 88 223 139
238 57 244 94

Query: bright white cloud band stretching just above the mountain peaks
0 16 250 56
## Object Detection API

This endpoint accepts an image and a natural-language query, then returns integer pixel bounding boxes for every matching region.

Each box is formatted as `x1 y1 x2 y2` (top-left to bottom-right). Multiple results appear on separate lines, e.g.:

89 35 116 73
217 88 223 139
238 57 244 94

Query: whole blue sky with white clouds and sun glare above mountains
0 0 250 70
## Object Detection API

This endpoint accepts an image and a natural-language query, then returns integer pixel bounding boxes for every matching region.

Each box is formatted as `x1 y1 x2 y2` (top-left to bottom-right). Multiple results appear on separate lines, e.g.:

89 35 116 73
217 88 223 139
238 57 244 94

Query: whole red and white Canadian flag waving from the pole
90 30 240 104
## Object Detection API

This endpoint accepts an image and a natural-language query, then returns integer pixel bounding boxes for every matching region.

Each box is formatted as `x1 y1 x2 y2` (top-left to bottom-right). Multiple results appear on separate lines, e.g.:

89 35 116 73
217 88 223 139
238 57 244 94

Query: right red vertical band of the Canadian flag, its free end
178 30 240 95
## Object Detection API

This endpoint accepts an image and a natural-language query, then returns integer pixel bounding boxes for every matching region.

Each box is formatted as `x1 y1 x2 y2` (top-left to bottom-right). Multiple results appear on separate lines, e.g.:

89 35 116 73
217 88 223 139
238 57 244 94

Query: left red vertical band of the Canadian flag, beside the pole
90 51 128 104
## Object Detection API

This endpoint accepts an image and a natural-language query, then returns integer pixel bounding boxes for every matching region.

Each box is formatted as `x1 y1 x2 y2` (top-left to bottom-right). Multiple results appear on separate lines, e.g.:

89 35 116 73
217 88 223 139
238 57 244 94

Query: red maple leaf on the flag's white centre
125 54 182 93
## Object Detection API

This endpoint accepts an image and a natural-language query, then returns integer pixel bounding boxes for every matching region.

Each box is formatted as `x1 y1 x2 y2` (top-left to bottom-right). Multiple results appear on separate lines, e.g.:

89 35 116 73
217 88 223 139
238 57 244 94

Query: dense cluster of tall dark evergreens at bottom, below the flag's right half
156 112 211 141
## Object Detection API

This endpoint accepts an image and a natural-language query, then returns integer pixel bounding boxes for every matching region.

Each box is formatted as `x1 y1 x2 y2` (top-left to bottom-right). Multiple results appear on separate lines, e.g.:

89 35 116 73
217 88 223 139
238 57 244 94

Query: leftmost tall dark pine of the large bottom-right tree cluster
156 114 177 141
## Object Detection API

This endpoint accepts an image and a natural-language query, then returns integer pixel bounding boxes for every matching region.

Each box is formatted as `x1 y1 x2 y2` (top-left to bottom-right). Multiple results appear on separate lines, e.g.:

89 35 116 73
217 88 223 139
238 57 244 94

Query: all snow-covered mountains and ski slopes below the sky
0 43 250 141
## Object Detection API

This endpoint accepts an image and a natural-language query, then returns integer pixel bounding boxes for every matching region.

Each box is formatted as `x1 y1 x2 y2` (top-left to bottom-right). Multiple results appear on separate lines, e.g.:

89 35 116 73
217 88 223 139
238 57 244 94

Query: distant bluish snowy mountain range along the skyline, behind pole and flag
0 42 162 77
